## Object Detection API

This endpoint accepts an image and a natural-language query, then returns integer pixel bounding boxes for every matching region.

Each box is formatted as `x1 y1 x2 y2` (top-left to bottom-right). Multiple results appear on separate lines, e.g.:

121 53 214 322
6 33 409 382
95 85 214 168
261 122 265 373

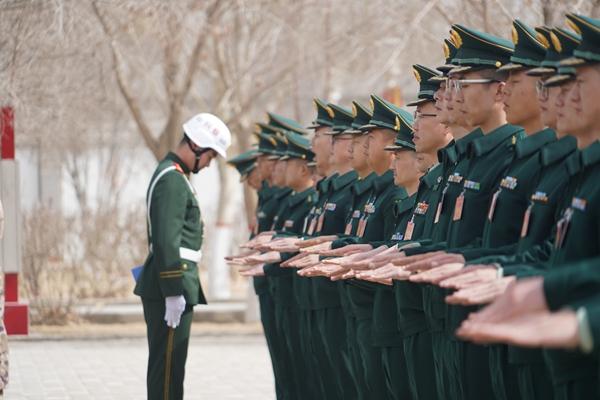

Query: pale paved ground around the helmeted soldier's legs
5 335 274 400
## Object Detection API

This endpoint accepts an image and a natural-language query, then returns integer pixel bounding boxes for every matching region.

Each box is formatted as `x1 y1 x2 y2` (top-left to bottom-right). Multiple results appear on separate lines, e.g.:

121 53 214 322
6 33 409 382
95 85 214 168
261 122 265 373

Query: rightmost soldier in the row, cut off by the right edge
450 14 600 399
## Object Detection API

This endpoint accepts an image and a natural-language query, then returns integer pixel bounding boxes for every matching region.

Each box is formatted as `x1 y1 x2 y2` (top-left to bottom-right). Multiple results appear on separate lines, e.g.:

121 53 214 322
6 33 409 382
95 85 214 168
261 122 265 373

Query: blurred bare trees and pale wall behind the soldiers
0 0 600 324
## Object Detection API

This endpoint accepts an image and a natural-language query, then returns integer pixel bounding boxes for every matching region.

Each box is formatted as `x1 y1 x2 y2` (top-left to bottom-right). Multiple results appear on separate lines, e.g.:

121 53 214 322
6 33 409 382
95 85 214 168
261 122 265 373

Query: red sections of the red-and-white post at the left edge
0 107 29 335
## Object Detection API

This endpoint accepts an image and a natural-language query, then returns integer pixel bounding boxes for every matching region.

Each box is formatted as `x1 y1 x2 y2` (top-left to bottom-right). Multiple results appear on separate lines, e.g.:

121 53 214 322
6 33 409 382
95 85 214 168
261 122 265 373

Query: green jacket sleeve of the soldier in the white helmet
150 172 189 297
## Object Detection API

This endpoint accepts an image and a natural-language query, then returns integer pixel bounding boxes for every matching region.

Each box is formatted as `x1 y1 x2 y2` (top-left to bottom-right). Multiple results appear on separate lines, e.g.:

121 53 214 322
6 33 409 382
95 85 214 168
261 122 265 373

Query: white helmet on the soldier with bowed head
183 113 231 157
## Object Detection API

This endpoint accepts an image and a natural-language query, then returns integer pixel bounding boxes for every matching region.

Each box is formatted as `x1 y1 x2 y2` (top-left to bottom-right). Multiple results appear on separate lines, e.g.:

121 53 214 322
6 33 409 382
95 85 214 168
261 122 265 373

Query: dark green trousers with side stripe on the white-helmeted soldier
142 299 193 400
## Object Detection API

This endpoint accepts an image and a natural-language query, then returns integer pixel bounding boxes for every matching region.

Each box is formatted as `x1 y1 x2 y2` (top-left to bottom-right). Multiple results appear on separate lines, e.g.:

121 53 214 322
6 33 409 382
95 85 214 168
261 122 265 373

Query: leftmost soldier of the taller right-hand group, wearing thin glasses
364 64 452 399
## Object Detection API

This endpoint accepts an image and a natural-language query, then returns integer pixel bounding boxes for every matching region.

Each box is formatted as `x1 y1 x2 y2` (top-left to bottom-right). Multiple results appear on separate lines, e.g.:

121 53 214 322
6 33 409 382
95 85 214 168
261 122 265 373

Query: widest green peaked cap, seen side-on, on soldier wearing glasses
450 24 514 73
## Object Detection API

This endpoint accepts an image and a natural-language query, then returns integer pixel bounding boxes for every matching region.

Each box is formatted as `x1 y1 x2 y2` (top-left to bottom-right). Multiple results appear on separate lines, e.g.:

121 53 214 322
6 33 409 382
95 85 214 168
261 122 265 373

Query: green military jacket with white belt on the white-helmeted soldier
134 153 206 305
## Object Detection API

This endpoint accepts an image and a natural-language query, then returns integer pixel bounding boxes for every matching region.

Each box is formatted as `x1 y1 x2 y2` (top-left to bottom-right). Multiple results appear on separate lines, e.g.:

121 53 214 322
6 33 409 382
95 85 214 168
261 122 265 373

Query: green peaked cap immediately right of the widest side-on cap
498 19 548 72
